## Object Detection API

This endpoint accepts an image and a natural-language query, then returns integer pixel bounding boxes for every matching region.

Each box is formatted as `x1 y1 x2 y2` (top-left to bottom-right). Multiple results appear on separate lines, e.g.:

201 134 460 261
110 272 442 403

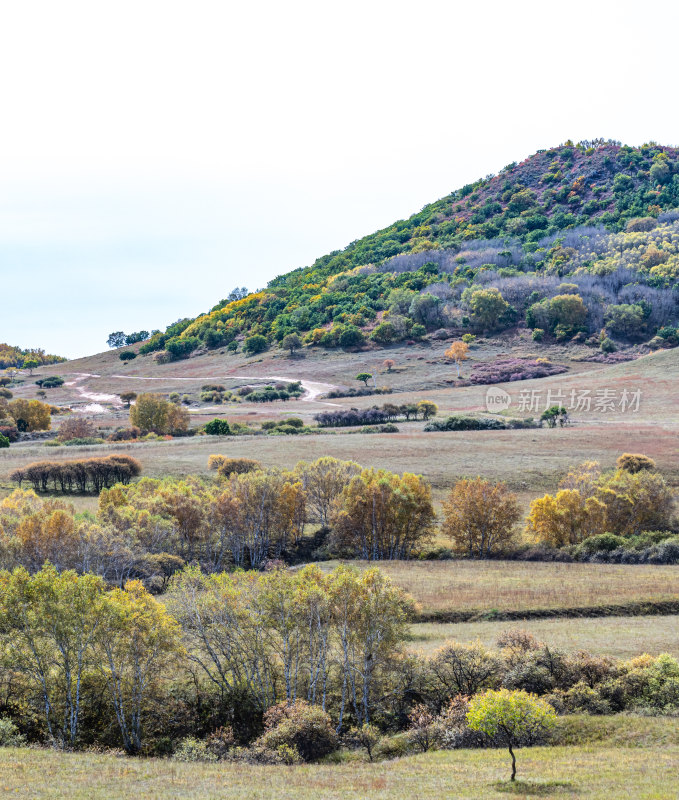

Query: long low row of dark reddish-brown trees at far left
10 455 141 494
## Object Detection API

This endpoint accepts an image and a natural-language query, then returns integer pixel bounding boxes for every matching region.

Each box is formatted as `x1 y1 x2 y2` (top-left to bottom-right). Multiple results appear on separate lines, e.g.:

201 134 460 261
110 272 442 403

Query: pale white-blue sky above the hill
0 0 679 357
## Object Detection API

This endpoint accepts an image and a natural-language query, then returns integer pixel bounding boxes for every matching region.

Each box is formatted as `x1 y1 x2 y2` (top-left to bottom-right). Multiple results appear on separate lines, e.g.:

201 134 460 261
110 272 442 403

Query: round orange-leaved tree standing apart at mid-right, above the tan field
441 478 521 558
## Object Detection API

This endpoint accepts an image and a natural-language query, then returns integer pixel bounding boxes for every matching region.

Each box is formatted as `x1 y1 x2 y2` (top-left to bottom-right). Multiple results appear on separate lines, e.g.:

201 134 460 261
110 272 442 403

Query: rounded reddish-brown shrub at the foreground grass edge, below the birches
258 700 339 761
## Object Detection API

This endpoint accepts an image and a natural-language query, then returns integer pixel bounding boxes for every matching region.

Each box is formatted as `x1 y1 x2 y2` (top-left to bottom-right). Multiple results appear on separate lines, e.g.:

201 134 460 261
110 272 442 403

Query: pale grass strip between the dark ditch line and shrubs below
409 615 679 659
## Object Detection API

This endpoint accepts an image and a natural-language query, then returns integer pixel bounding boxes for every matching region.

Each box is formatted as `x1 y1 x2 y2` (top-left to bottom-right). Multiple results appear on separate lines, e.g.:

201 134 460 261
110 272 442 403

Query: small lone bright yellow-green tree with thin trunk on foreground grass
467 689 556 781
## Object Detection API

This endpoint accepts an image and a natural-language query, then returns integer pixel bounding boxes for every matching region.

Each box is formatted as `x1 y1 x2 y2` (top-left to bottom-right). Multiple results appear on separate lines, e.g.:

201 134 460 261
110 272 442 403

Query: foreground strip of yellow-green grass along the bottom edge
0 717 679 800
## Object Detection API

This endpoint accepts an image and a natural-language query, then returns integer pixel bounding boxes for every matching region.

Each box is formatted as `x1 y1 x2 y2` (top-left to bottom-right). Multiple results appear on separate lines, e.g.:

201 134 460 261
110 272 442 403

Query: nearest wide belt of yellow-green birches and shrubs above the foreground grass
0 564 679 774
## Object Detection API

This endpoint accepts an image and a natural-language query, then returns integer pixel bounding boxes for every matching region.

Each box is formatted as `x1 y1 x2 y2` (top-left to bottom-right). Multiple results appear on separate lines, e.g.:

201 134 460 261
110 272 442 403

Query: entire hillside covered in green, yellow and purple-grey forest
134 140 679 360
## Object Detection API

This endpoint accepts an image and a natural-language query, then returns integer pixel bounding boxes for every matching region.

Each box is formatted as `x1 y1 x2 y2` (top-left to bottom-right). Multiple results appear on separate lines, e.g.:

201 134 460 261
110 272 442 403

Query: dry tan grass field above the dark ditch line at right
321 561 679 625
